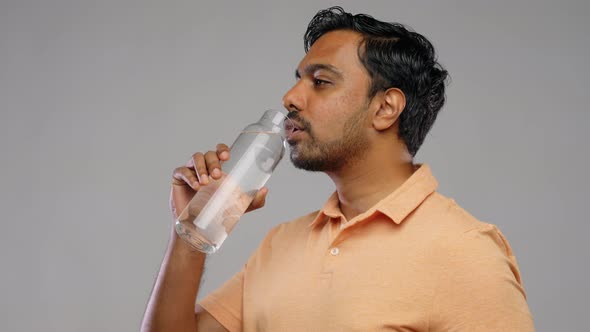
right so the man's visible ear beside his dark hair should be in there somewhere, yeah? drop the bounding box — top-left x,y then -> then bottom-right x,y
373,88 -> 406,131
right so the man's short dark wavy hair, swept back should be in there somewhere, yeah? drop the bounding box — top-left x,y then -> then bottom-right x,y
303,7 -> 448,156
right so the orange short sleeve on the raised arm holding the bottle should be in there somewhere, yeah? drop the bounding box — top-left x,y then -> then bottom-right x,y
199,265 -> 246,332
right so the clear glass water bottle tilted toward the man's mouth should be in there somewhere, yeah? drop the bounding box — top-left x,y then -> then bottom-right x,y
175,110 -> 290,254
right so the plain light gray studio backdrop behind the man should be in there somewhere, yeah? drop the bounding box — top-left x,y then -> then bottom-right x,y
0,0 -> 590,331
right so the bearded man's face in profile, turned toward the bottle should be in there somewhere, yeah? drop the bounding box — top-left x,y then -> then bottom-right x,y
283,31 -> 370,171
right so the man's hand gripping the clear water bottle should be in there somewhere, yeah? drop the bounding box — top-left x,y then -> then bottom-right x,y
170,144 -> 268,220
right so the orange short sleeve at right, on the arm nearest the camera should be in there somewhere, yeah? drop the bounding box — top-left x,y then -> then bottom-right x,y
429,224 -> 534,332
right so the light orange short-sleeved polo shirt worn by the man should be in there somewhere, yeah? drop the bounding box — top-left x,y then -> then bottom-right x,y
199,164 -> 534,331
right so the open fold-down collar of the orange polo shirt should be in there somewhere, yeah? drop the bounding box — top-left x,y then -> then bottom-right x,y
309,164 -> 438,227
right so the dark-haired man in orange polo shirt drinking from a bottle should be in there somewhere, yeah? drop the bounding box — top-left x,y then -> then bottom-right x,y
143,7 -> 534,331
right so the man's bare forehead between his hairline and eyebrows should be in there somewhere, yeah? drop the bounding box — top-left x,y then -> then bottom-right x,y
299,30 -> 364,75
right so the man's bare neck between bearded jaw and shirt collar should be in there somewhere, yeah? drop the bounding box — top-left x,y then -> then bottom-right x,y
327,139 -> 414,220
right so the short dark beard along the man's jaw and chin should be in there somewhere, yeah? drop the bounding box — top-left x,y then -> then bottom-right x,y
290,108 -> 369,172
